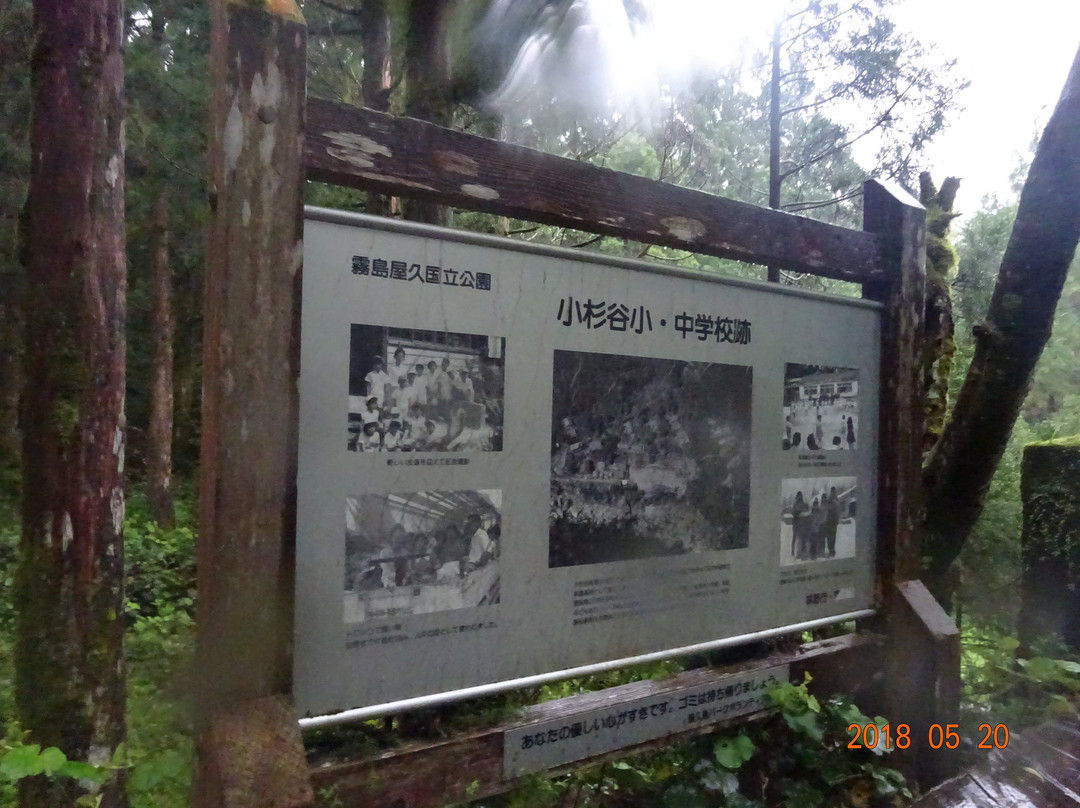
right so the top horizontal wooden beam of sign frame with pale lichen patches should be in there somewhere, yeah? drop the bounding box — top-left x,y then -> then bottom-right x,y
305,98 -> 886,283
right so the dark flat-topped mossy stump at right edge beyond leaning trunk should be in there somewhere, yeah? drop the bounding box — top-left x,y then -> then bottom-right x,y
1020,435 -> 1080,655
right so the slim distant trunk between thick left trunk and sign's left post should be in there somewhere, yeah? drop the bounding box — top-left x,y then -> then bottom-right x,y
146,193 -> 176,529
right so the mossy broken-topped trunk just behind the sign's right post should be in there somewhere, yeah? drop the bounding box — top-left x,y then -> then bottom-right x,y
919,172 -> 960,452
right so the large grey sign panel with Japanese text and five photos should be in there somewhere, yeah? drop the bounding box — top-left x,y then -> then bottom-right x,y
294,211 -> 880,714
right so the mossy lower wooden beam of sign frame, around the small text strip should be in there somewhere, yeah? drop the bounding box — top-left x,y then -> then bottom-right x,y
311,633 -> 881,808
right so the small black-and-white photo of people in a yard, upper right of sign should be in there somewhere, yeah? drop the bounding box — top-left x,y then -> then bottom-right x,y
783,363 -> 859,452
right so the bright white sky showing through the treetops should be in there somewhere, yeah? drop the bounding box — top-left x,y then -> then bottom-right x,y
490,0 -> 1080,211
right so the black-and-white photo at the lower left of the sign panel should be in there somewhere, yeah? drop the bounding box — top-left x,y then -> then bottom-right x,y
345,489 -> 502,623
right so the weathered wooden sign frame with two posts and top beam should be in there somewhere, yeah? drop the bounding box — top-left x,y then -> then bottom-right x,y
193,0 -> 959,807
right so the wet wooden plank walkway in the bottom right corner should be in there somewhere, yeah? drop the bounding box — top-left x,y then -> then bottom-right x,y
912,719 -> 1080,808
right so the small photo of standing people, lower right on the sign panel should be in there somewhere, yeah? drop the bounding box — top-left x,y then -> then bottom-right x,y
780,476 -> 856,567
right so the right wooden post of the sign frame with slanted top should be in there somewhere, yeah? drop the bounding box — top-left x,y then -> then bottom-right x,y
863,180 -> 960,786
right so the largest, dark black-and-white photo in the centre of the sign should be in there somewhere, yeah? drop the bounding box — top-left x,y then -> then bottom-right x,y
548,351 -> 753,567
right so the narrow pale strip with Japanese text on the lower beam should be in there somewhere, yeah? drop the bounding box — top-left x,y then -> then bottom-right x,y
502,664 -> 788,780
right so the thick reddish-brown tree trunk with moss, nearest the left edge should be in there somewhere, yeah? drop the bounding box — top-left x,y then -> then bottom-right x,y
15,0 -> 126,807
